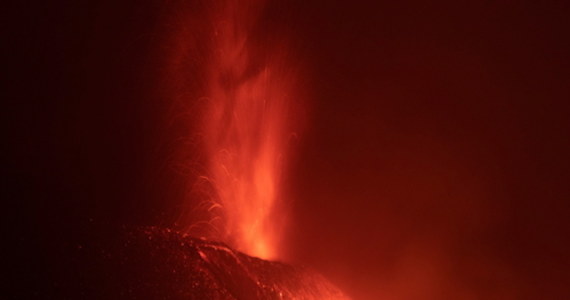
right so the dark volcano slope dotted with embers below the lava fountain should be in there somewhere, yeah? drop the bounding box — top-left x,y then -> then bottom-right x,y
113,227 -> 348,300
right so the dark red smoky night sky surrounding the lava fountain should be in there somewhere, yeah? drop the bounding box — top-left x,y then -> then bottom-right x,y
5,1 -> 570,299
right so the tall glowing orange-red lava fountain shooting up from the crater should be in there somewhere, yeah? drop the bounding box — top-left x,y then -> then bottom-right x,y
203,1 -> 300,259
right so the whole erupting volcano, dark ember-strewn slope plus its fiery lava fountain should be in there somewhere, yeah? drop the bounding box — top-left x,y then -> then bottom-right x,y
131,0 -> 346,299
